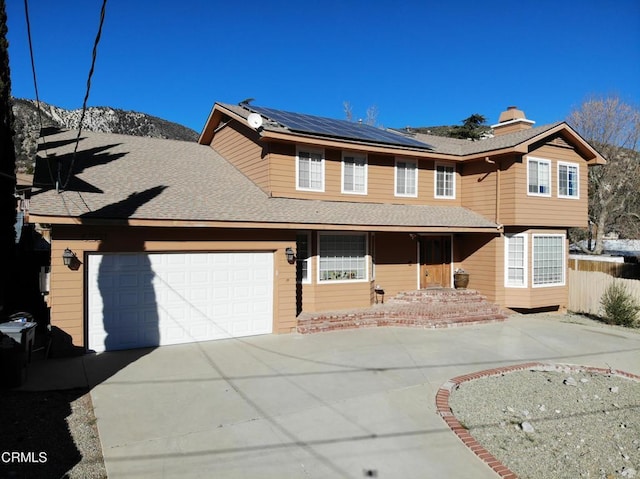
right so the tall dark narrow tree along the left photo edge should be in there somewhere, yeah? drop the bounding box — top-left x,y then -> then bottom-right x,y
0,0 -> 16,314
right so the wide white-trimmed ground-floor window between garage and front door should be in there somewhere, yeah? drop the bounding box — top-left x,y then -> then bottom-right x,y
318,233 -> 367,282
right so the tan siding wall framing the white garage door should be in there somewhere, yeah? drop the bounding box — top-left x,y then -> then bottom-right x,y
50,226 -> 297,346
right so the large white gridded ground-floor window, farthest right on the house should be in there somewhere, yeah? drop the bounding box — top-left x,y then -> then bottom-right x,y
532,234 -> 566,287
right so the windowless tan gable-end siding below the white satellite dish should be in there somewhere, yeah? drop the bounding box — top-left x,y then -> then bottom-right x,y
211,122 -> 269,193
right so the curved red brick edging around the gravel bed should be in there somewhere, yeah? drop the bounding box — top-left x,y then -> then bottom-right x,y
436,362 -> 640,479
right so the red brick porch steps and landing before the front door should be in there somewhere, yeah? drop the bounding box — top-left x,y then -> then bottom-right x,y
298,288 -> 508,334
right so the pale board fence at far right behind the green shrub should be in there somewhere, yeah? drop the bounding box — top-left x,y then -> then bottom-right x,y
568,270 -> 640,316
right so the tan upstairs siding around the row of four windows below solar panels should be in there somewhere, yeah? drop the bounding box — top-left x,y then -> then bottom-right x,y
269,143 -> 462,206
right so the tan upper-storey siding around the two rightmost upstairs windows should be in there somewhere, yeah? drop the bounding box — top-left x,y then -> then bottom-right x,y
500,144 -> 588,227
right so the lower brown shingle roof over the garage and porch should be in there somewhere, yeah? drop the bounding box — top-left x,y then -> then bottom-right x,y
30,131 -> 496,228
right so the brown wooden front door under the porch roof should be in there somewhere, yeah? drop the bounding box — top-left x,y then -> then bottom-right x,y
420,236 -> 451,289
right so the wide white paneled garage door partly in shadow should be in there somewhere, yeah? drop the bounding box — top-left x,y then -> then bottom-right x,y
88,253 -> 273,352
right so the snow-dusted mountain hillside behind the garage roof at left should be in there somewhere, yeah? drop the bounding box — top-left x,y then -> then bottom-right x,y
13,98 -> 199,173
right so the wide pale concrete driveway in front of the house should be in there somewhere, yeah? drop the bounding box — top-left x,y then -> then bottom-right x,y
75,315 -> 640,479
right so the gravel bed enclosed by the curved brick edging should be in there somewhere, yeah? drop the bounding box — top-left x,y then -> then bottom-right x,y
449,366 -> 640,479
